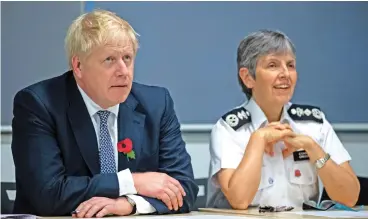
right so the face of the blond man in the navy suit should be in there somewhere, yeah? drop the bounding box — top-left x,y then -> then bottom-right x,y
74,40 -> 135,109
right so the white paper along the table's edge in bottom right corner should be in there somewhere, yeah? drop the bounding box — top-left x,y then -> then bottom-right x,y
287,211 -> 368,218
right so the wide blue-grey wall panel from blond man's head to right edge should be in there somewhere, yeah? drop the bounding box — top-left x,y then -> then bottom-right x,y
85,2 -> 368,123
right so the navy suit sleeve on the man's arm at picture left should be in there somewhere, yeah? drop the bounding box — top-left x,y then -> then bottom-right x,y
12,90 -> 119,216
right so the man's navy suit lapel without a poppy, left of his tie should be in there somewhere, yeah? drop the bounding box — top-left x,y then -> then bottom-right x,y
68,76 -> 100,175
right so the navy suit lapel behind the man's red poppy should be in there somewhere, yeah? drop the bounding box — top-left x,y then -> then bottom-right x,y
118,94 -> 145,172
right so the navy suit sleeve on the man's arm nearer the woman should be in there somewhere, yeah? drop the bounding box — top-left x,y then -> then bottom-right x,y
140,89 -> 198,214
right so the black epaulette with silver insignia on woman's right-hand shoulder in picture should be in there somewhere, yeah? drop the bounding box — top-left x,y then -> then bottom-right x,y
288,104 -> 323,123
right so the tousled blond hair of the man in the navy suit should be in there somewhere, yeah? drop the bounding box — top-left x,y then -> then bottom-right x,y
65,10 -> 139,68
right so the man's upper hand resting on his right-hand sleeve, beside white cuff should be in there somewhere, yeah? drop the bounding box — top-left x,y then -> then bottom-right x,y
132,172 -> 185,211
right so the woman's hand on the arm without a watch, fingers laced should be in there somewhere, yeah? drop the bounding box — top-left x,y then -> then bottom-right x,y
255,122 -> 295,156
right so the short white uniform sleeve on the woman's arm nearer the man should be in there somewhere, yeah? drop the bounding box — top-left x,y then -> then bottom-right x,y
210,120 -> 246,181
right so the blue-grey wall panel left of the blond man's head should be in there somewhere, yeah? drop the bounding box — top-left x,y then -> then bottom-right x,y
1,2 -> 83,125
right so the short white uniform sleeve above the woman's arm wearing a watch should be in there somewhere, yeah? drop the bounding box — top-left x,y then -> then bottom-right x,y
322,120 -> 351,165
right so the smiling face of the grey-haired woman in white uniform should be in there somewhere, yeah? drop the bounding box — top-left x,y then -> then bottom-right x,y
247,53 -> 298,106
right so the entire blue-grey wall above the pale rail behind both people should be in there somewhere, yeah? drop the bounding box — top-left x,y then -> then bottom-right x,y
1,2 -> 368,125
